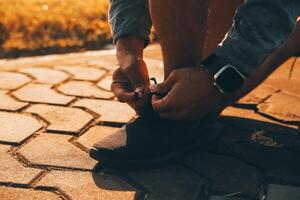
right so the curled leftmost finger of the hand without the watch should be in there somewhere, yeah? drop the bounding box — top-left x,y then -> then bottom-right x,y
111,83 -> 136,103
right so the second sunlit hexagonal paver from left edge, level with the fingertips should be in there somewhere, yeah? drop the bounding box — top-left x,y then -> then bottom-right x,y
12,83 -> 74,105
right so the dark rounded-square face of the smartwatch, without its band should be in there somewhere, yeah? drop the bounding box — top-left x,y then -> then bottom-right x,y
215,66 -> 244,93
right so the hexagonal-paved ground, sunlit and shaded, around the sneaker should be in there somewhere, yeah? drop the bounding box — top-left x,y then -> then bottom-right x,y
0,46 -> 300,200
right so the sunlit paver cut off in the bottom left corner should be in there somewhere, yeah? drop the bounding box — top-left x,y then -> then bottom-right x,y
0,186 -> 61,200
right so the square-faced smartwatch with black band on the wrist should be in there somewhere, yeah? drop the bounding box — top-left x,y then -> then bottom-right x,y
201,54 -> 245,95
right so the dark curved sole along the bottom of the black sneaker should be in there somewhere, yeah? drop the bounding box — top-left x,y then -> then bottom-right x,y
89,124 -> 221,170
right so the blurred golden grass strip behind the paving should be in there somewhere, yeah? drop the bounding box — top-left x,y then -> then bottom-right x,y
0,0 -> 111,57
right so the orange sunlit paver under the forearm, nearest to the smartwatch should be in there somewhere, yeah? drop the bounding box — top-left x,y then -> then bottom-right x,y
238,84 -> 278,104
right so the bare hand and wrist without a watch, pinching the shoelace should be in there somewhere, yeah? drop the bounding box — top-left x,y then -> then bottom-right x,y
111,36 -> 149,114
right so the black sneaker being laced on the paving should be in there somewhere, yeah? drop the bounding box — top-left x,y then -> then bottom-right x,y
90,113 -> 221,169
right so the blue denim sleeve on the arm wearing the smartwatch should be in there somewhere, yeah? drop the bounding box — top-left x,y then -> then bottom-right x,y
215,0 -> 300,76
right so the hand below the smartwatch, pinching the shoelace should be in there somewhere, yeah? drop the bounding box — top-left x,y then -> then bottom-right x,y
150,67 -> 222,121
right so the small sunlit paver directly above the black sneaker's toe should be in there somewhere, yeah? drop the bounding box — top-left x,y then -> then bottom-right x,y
77,126 -> 118,149
